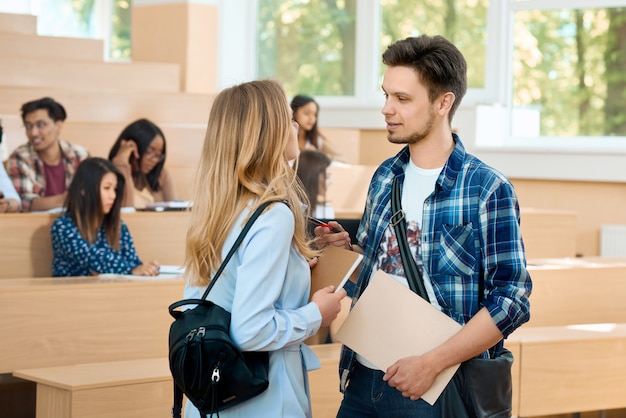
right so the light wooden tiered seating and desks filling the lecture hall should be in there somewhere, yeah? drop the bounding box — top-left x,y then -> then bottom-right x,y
0,9 -> 626,418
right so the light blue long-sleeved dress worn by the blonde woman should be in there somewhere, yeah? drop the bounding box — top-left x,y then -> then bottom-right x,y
184,203 -> 322,418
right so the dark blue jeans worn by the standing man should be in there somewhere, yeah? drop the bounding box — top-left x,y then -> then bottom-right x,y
337,361 -> 441,418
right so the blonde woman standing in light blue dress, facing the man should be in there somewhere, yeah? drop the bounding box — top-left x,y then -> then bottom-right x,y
184,80 -> 345,418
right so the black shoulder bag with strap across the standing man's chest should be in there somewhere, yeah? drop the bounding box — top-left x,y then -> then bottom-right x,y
391,178 -> 513,418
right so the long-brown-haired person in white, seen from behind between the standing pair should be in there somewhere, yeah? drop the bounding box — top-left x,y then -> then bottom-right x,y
296,149 -> 335,219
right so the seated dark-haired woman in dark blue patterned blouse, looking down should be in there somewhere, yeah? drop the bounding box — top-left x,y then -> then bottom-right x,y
51,158 -> 159,276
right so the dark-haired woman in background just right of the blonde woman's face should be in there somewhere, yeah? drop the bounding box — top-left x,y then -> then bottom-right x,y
291,94 -> 341,160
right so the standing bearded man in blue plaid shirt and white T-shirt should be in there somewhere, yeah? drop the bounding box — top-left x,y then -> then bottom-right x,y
316,36 -> 532,418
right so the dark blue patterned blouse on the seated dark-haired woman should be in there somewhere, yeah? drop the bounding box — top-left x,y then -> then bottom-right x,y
50,214 -> 141,277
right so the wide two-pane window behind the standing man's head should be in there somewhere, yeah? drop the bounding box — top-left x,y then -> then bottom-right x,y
256,0 -> 489,96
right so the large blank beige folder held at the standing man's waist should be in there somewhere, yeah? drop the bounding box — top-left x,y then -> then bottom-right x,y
335,270 -> 461,405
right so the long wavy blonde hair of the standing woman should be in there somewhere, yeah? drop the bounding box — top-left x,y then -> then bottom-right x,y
185,80 -> 316,286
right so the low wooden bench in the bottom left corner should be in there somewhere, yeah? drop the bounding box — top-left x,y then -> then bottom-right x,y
13,357 -> 173,418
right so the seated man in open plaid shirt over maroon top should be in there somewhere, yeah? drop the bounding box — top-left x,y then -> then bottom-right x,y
8,97 -> 89,212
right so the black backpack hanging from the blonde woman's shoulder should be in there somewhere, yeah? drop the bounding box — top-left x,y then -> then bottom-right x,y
169,202 -> 273,418
